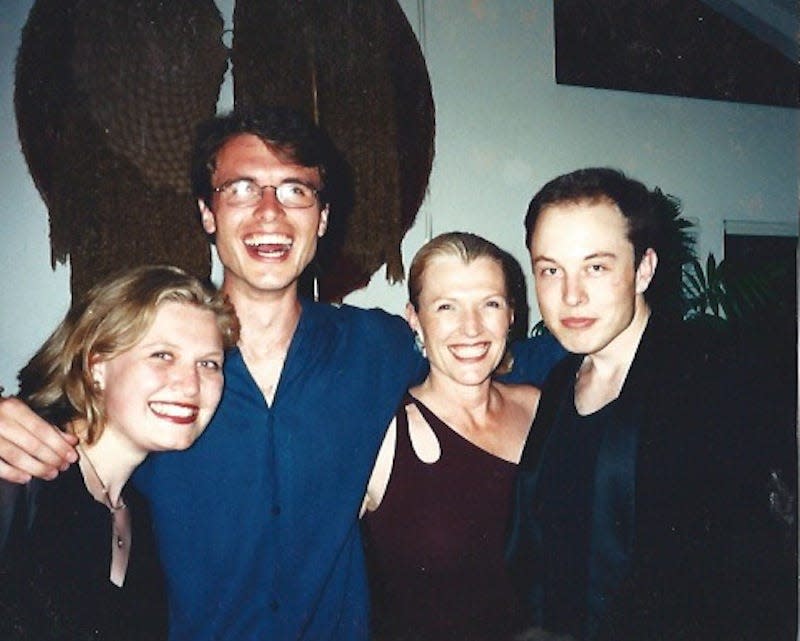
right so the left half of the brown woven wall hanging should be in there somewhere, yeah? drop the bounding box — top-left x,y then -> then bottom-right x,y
14,0 -> 227,296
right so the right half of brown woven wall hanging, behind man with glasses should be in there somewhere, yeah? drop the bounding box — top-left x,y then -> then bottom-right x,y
232,0 -> 434,300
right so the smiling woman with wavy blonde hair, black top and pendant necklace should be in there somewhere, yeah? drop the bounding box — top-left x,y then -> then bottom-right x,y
0,266 -> 238,641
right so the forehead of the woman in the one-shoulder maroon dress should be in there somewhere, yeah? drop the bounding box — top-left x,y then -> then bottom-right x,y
420,254 -> 506,296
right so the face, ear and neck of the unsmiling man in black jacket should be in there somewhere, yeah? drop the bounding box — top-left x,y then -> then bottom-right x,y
530,201 -> 658,415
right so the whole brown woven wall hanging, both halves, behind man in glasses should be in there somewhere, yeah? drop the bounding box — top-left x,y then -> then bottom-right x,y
14,0 -> 434,300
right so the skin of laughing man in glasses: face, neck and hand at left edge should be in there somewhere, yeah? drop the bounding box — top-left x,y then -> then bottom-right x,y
0,134 -> 328,483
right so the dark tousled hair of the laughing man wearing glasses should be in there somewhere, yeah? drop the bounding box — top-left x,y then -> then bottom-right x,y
191,106 -> 344,209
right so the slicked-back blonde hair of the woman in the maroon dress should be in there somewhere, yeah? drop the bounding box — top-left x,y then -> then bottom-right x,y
408,231 -> 516,374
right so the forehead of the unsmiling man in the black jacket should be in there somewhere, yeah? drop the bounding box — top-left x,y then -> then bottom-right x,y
531,201 -> 633,259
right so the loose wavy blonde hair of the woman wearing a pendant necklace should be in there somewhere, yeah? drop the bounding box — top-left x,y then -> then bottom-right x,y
19,265 -> 239,443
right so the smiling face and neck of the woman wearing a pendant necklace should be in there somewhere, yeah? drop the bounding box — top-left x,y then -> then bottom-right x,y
79,302 -> 224,500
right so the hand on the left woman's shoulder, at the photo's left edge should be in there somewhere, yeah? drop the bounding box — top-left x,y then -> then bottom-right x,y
0,397 -> 77,483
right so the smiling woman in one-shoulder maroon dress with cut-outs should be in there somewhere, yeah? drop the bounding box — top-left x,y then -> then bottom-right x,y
363,232 -> 539,641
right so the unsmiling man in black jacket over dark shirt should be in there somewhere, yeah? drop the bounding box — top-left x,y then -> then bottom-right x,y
508,169 -> 792,641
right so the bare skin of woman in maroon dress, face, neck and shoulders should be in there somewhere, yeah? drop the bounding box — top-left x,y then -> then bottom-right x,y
361,255 -> 539,515
